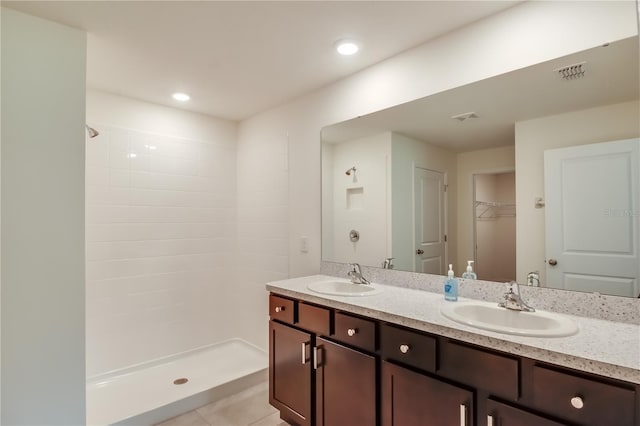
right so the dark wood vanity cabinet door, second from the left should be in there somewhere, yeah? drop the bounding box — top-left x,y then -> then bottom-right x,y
315,338 -> 376,426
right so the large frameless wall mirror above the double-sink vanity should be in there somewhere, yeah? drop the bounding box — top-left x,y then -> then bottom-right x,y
322,37 -> 640,297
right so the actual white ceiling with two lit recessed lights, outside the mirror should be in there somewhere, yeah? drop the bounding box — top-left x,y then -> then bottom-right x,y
2,0 -> 518,120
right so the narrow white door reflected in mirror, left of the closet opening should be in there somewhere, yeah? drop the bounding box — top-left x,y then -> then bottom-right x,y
414,167 -> 447,275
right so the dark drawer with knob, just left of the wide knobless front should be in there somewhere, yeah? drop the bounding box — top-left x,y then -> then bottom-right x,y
380,324 -> 436,372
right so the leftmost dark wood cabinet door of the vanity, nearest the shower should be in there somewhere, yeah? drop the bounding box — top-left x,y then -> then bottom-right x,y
269,321 -> 312,426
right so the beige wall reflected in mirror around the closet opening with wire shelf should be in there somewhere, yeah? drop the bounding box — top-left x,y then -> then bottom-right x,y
454,146 -> 515,274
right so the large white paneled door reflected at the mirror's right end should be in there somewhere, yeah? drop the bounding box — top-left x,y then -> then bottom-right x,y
544,139 -> 640,297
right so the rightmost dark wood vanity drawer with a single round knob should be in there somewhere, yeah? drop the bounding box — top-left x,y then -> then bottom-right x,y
532,365 -> 640,426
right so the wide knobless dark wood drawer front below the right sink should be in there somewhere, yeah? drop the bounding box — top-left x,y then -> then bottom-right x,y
440,340 -> 520,401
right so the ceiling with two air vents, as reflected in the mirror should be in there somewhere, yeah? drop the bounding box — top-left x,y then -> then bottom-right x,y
322,37 -> 640,152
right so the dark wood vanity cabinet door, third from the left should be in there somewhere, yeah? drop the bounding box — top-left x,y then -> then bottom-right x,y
381,361 -> 474,426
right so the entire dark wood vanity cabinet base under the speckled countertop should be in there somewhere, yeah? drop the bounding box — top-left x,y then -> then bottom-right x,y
269,295 -> 640,426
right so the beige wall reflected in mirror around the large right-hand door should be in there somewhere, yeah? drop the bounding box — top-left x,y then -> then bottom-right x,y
516,102 -> 640,286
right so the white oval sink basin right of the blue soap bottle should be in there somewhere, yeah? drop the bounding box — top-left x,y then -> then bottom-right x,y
440,301 -> 578,337
